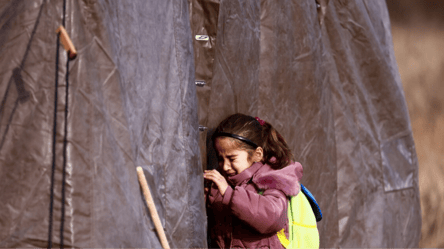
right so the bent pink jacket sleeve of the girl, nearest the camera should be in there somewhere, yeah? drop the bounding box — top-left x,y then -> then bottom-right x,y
223,186 -> 288,234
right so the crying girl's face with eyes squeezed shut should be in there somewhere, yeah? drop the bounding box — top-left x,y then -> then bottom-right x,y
214,137 -> 262,176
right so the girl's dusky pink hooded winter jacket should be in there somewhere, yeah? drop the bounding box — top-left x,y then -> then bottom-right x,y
208,162 -> 302,248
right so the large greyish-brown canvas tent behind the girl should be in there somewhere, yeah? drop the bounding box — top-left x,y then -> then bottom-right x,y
0,0 -> 421,248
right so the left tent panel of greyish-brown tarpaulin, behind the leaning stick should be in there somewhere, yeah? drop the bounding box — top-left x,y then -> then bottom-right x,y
0,0 -> 206,248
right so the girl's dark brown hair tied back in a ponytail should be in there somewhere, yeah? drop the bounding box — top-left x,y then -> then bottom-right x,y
212,113 -> 294,169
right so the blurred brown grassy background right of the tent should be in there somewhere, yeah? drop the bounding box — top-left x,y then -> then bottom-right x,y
387,0 -> 444,248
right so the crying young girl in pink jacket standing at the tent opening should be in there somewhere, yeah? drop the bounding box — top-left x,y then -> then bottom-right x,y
204,114 -> 302,248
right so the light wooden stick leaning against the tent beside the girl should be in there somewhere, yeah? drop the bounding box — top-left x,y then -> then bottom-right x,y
137,166 -> 170,249
